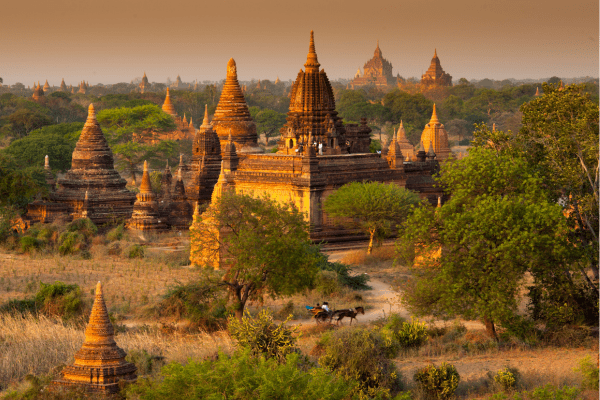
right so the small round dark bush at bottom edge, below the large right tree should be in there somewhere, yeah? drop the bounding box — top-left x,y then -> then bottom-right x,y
414,363 -> 460,400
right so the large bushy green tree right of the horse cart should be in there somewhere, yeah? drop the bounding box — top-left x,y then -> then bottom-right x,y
399,148 -> 579,339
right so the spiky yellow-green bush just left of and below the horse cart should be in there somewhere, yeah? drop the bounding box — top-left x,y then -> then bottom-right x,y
228,309 -> 298,362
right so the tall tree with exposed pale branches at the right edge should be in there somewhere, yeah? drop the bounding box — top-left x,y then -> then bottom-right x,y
513,83 -> 600,280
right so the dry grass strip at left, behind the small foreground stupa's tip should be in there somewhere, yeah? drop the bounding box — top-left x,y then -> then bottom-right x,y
0,245 -> 197,314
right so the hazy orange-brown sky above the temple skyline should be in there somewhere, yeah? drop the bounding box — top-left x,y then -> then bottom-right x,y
0,0 -> 599,86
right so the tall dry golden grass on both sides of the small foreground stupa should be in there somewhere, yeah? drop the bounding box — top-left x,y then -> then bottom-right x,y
0,315 -> 232,388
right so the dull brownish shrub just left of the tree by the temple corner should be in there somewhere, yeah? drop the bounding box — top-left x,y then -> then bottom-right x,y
156,277 -> 227,331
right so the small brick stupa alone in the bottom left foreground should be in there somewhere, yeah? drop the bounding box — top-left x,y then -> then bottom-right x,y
51,282 -> 137,395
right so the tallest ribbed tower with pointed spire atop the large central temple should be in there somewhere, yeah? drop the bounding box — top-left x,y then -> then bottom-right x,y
278,31 -> 348,154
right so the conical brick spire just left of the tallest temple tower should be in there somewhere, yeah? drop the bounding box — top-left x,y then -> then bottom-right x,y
212,58 -> 262,153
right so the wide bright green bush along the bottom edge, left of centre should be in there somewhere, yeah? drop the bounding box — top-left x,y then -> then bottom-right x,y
127,351 -> 356,400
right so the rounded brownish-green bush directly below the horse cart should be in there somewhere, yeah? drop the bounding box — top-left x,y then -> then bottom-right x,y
318,328 -> 400,397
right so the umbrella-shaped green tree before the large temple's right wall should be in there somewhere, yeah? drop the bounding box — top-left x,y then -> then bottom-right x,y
323,182 -> 419,254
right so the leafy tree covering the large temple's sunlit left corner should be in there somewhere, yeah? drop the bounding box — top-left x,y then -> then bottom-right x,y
190,192 -> 319,320
